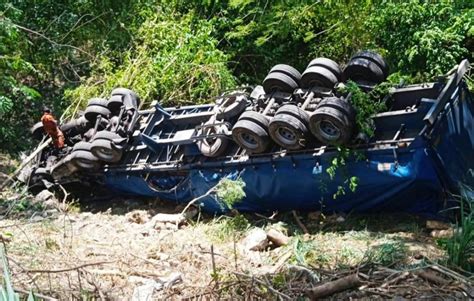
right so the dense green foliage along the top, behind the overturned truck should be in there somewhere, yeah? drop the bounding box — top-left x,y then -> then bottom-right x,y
0,0 -> 474,152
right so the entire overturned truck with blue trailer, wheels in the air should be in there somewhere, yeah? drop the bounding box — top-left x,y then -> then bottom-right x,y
28,51 -> 474,214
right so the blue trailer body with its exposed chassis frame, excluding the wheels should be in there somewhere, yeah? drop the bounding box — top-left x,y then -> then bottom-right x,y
105,61 -> 474,215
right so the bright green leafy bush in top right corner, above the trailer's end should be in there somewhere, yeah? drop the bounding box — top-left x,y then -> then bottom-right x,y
367,0 -> 474,80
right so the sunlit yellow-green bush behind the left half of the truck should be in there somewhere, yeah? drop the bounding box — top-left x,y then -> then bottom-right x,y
67,11 -> 235,113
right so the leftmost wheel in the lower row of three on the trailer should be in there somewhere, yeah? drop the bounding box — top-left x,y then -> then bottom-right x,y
232,115 -> 270,154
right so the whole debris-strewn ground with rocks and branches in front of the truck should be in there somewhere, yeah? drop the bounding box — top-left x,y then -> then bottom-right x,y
0,166 -> 473,300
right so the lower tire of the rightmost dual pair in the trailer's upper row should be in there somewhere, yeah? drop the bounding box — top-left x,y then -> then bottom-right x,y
344,58 -> 385,84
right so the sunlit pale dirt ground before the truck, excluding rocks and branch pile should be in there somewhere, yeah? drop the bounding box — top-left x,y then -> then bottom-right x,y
0,184 -> 462,300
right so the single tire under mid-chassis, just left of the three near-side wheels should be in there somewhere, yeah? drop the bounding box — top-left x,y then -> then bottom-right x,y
196,121 -> 229,157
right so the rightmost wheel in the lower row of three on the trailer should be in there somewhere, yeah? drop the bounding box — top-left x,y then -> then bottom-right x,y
309,107 -> 354,145
